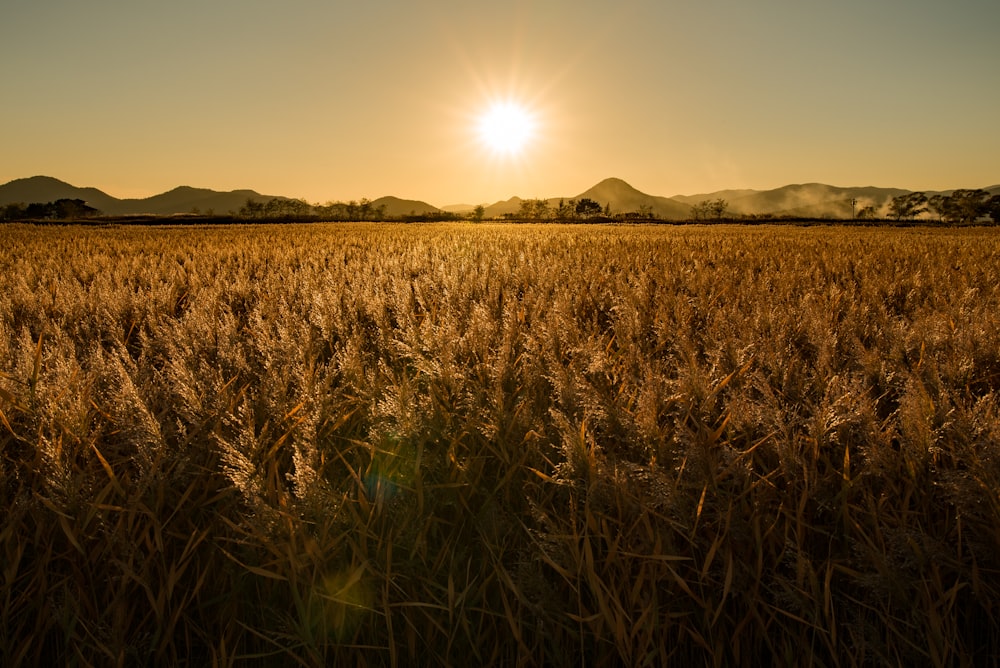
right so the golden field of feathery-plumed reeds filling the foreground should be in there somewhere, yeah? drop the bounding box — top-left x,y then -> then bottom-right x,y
0,224 -> 1000,666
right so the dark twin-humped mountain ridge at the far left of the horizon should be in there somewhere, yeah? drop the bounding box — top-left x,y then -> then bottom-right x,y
0,176 -> 286,216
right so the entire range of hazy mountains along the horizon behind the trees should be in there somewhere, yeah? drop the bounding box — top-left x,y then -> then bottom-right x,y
0,176 -> 1000,220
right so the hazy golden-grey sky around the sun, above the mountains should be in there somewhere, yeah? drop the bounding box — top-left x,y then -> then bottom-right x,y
0,0 -> 1000,206
